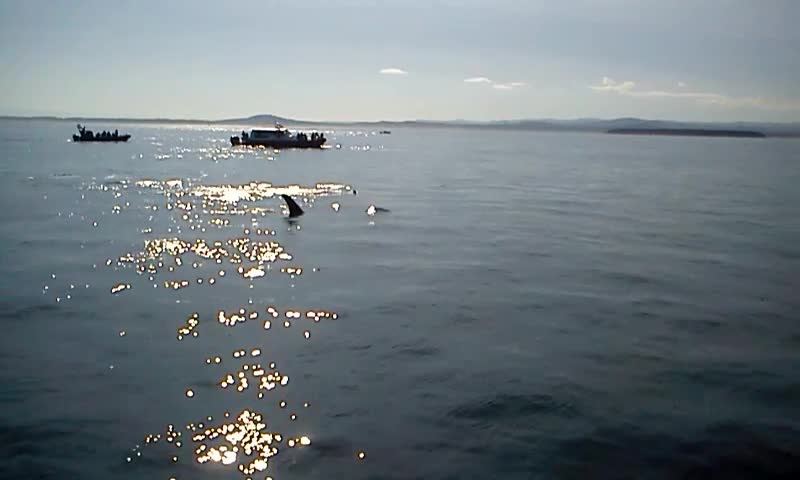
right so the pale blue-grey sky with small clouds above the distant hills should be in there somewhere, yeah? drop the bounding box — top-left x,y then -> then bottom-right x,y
0,0 -> 800,121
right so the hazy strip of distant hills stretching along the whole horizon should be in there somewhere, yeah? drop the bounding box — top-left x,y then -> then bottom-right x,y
0,114 -> 800,137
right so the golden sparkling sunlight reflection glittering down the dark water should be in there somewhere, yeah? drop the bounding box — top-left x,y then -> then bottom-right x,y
90,174 -> 364,478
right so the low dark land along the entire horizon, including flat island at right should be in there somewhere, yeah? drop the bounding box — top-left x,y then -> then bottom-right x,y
0,114 -> 800,138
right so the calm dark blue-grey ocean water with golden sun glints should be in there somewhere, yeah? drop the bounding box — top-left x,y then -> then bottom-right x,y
0,121 -> 800,480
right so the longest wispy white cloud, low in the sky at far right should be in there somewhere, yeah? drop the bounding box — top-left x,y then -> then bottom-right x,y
589,77 -> 800,110
